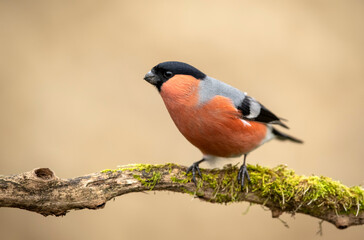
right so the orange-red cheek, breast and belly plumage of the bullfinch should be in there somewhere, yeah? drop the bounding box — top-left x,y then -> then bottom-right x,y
160,75 -> 267,157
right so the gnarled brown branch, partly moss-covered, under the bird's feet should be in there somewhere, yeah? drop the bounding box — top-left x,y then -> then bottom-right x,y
0,163 -> 364,229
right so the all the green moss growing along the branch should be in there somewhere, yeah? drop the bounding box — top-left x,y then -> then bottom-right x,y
102,163 -> 364,214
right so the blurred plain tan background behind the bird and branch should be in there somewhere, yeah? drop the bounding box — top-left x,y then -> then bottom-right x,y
0,0 -> 364,240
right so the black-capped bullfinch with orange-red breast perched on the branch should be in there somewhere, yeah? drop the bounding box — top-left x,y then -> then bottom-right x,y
144,61 -> 303,189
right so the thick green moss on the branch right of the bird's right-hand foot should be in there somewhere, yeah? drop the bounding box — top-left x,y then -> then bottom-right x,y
249,165 -> 364,213
